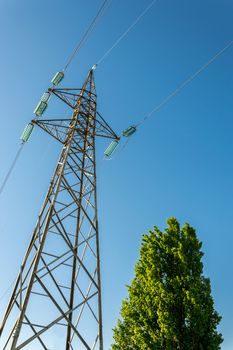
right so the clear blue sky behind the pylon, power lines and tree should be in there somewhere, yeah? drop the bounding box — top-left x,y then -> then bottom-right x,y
0,0 -> 233,350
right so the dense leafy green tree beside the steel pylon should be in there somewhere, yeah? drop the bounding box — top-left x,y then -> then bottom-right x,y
112,218 -> 223,350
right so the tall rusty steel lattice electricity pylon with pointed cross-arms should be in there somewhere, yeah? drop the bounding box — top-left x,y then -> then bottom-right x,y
0,70 -> 118,350
